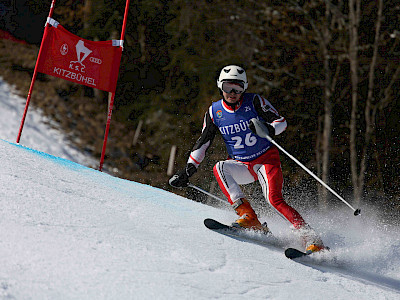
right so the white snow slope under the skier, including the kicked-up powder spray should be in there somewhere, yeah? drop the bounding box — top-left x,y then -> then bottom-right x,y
0,81 -> 400,300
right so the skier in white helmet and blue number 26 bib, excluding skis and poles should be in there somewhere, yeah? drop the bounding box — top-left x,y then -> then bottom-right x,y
169,65 -> 325,253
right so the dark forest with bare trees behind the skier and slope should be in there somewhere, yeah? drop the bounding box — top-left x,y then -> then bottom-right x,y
0,0 -> 400,216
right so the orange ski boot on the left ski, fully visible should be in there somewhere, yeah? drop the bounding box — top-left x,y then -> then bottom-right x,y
232,198 -> 270,233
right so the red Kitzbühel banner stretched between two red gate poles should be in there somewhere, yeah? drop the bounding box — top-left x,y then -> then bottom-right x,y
37,24 -> 122,93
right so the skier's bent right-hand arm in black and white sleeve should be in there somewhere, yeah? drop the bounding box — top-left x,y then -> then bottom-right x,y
253,95 -> 287,136
